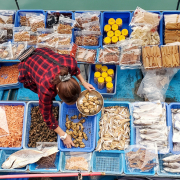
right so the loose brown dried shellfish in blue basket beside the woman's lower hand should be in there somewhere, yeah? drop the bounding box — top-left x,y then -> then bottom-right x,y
65,113 -> 88,148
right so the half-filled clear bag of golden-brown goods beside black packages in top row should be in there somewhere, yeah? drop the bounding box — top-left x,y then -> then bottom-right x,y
57,15 -> 75,34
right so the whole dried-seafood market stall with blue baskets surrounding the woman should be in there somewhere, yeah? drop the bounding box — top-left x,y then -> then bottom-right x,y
0,7 -> 180,179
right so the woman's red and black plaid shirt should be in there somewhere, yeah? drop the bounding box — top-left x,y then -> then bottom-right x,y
18,48 -> 80,129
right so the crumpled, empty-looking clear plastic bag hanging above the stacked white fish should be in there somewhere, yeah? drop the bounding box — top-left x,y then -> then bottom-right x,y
137,68 -> 178,102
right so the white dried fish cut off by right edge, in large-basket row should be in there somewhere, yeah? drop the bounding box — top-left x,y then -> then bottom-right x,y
171,109 -> 180,151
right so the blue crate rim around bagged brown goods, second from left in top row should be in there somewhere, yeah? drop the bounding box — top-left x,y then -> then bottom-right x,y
15,9 -> 46,27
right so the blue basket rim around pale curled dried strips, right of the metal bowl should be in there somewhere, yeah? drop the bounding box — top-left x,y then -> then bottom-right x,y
96,101 -> 134,153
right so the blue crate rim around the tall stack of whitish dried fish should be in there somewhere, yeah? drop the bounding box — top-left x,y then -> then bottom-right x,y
131,102 -> 172,153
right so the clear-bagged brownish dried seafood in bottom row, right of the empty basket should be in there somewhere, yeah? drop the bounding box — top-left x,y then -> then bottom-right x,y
125,148 -> 157,171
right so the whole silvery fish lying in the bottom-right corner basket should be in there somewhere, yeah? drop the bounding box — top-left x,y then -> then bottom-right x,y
162,154 -> 180,173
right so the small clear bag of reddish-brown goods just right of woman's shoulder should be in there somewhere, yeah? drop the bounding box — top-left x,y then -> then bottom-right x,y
75,47 -> 97,63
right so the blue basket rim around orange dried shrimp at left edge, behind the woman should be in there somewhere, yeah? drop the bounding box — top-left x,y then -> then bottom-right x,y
0,61 -> 21,90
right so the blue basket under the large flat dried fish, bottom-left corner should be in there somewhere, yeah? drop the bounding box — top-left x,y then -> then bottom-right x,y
0,150 -> 27,172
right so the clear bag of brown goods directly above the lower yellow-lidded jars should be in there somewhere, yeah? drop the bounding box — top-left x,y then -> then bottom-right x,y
99,45 -> 120,64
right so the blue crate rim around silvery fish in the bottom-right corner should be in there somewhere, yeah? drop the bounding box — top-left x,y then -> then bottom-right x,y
157,154 -> 180,177
